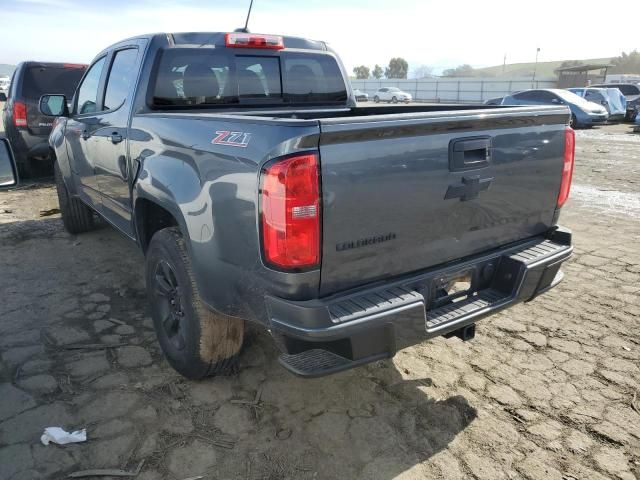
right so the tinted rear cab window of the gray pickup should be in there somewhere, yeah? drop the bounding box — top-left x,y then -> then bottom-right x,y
151,48 -> 347,109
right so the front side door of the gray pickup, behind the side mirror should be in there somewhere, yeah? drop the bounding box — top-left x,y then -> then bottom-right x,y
65,56 -> 107,211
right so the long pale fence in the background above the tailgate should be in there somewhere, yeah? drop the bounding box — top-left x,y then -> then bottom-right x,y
351,77 -> 557,103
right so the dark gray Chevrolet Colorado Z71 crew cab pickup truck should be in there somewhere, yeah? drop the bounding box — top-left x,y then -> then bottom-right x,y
27,33 -> 574,378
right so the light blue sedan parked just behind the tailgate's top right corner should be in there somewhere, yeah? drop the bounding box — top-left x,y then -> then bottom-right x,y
502,88 -> 609,128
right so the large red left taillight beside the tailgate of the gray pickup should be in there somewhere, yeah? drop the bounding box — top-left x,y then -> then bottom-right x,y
261,153 -> 321,269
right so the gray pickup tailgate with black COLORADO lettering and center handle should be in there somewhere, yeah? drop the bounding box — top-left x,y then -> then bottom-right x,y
320,107 -> 568,295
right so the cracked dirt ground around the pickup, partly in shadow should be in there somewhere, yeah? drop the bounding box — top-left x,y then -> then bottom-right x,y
0,119 -> 640,480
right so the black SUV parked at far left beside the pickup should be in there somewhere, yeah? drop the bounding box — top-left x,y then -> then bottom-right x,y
2,62 -> 86,177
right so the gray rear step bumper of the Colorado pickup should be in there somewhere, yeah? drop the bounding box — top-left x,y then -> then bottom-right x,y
266,228 -> 573,377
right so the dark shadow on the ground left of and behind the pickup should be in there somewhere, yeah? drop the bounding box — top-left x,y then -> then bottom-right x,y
0,215 -> 477,480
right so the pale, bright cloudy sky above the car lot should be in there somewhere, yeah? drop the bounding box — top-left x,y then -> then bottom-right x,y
0,0 -> 640,73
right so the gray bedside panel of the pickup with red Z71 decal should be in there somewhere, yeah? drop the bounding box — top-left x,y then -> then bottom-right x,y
129,113 -> 319,321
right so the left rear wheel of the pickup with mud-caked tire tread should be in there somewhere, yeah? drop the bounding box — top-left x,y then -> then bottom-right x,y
145,227 -> 244,379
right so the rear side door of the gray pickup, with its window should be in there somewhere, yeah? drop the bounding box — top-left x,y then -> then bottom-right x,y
93,45 -> 142,236
